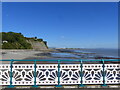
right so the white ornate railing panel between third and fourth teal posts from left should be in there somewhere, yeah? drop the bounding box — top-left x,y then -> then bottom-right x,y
60,64 -> 81,85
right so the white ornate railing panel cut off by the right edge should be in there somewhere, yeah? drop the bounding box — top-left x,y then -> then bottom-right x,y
105,64 -> 120,84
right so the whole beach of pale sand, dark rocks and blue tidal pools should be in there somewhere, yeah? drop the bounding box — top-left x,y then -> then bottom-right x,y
0,49 -> 119,64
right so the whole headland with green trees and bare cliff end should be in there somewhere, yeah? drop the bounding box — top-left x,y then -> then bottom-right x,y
0,32 -> 48,50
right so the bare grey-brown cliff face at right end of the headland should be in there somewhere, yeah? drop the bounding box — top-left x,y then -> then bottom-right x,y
27,40 -> 48,50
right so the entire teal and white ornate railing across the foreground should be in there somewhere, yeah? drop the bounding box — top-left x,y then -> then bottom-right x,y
0,59 -> 120,87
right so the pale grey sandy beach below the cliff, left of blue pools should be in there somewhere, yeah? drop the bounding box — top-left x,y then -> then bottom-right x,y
0,49 -> 78,64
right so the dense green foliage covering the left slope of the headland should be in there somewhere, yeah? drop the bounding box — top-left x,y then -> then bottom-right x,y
0,32 -> 32,49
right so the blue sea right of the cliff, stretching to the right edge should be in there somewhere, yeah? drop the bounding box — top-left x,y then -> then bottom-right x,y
52,48 -> 120,59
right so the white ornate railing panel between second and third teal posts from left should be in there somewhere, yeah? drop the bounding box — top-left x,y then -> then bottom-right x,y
36,64 -> 58,85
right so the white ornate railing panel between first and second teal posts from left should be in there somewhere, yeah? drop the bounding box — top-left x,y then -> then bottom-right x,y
12,64 -> 34,85
